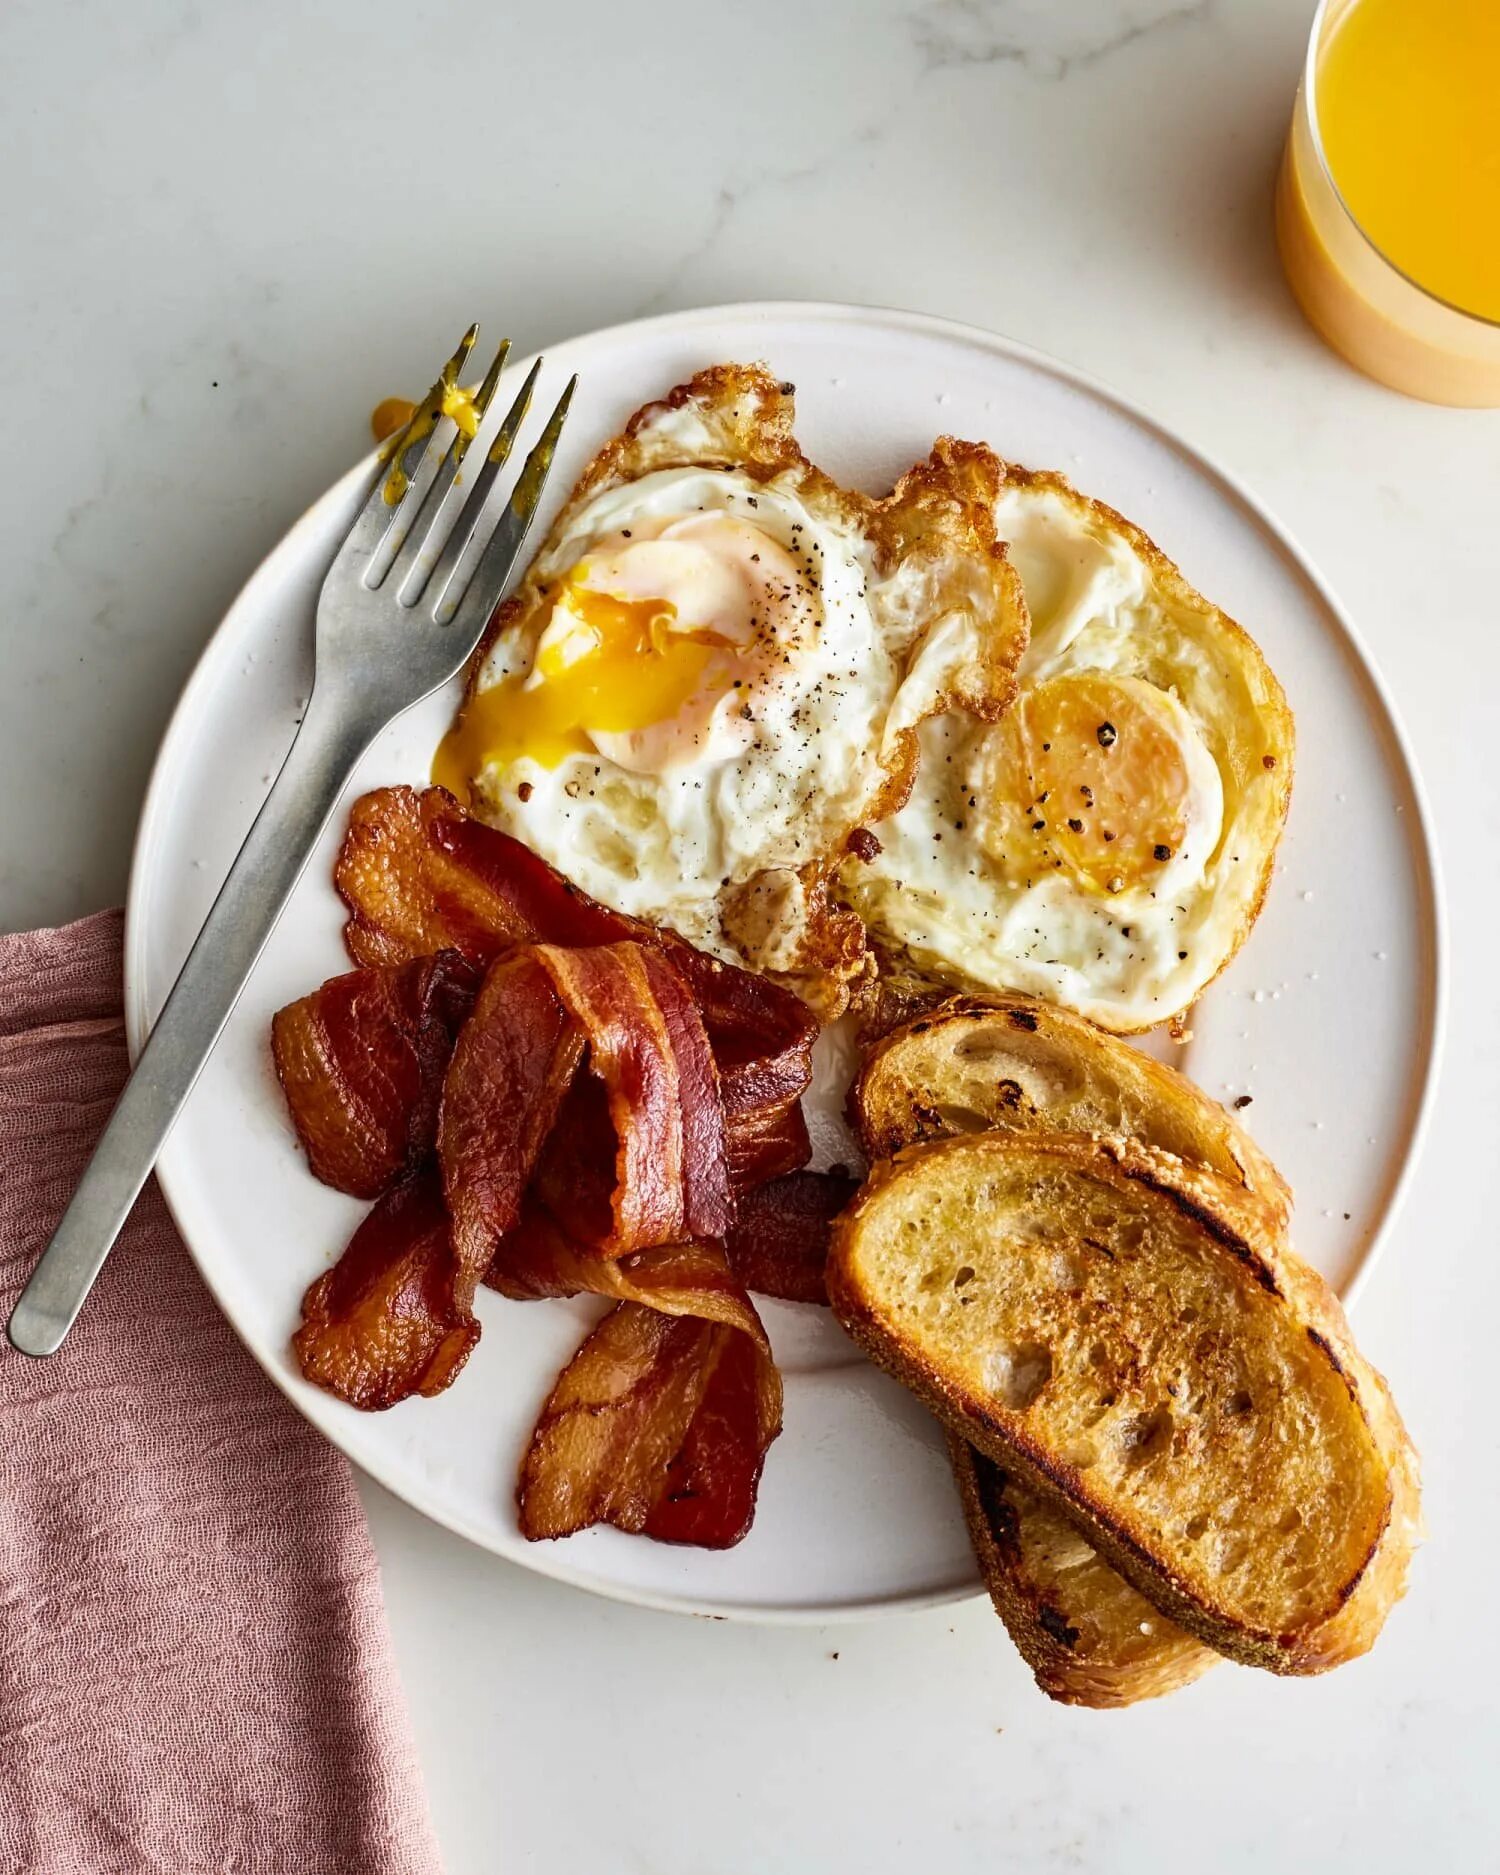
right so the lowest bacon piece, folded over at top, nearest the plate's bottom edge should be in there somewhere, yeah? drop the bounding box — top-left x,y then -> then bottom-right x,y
518,1232 -> 782,1549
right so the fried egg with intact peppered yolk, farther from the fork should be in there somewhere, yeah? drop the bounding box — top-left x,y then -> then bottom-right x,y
842,467 -> 1292,1033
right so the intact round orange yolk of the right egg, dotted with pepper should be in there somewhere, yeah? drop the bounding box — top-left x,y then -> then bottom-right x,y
984,671 -> 1223,894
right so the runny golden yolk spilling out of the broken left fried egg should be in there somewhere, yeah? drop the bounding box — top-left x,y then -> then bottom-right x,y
433,566 -> 722,804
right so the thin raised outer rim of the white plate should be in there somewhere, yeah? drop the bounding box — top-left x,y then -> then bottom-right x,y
124,300 -> 1449,1626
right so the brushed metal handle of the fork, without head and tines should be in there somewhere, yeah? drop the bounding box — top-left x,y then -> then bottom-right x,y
8,688 -> 379,1356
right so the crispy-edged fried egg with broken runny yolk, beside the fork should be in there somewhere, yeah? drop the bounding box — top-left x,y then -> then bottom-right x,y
433,366 -> 1026,1013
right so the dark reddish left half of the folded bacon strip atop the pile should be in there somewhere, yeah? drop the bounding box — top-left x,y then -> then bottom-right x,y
437,947 -> 585,1307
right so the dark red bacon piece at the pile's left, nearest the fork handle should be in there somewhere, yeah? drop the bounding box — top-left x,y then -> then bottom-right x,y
272,951 -> 480,1198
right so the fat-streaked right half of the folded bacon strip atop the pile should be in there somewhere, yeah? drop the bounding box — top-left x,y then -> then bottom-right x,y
534,943 -> 733,1256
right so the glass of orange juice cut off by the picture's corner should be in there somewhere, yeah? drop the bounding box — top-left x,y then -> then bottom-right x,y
1277,0 -> 1500,405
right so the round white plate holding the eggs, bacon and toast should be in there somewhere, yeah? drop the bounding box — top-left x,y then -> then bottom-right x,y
126,304 -> 1440,1620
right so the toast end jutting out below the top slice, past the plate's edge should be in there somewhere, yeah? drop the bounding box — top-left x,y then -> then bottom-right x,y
949,1433 -> 1219,1708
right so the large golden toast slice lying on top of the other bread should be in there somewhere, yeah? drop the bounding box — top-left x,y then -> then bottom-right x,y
829,1133 -> 1419,1673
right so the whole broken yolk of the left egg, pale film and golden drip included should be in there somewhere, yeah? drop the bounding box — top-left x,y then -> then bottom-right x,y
433,514 -> 816,801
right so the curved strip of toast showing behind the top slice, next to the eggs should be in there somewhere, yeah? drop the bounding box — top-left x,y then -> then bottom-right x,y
849,994 -> 1292,1230
